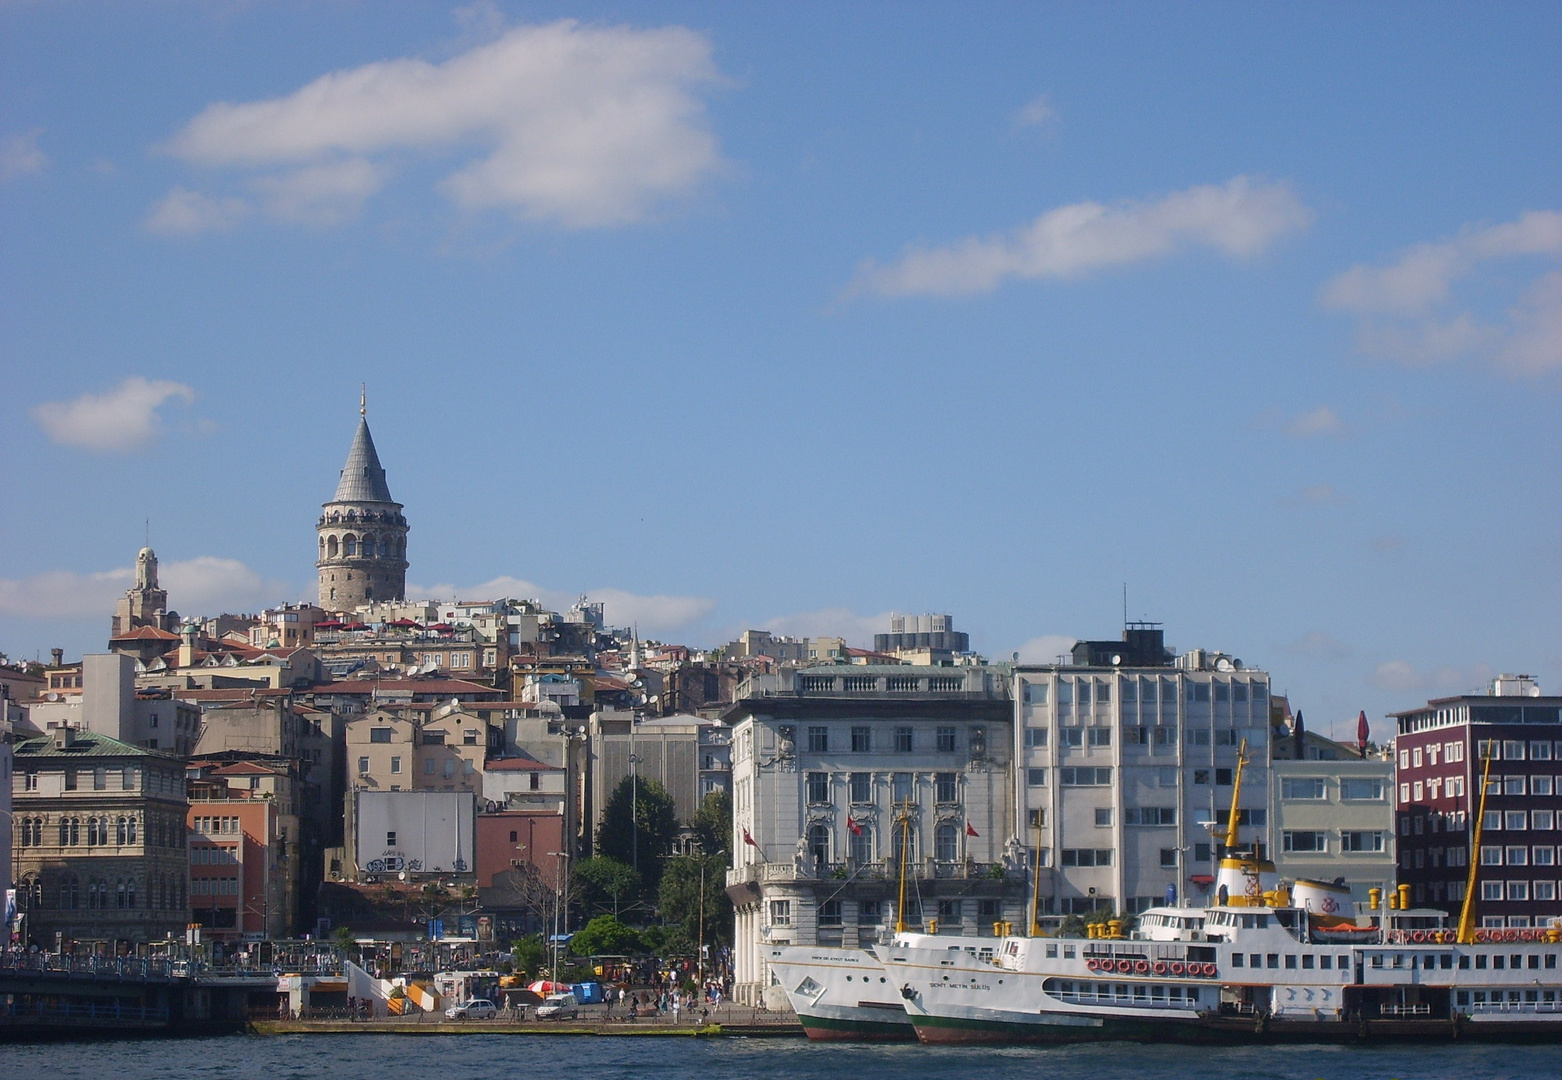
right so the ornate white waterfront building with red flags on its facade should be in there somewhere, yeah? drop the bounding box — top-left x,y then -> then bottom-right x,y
723,666 -> 1028,1002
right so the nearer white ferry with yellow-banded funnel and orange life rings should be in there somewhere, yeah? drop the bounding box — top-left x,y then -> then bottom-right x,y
883,747 -> 1562,1042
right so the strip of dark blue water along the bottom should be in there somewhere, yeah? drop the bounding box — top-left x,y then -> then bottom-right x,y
0,1035 -> 1562,1080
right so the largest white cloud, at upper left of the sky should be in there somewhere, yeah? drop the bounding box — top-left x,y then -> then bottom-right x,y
156,19 -> 722,228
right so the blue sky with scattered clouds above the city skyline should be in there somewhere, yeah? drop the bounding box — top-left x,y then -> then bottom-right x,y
0,0 -> 1562,736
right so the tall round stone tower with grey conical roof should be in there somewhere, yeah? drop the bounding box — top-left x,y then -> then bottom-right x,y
316,395 -> 406,611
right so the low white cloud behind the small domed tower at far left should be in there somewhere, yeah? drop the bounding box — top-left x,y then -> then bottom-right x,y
0,555 -> 292,615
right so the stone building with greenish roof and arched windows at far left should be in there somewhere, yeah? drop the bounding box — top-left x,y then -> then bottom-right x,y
12,728 -> 189,947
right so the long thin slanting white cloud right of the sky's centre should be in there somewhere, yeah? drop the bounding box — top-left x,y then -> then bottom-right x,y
847,177 -> 1312,297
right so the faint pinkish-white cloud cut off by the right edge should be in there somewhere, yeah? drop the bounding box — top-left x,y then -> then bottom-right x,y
1318,209 -> 1562,377
